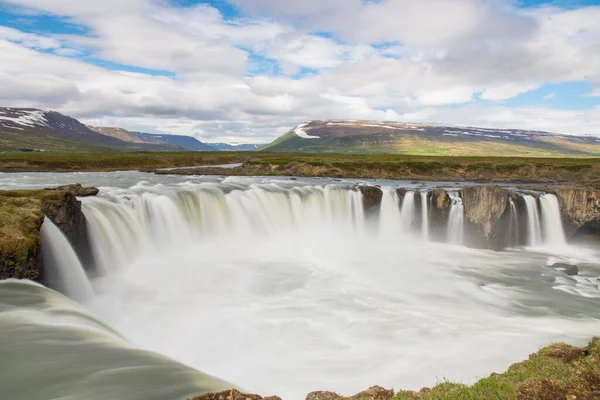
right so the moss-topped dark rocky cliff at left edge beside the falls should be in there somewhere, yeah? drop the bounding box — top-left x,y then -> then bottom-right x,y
0,185 -> 97,281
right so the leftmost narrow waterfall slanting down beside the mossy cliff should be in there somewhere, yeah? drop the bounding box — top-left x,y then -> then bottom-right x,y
40,218 -> 94,300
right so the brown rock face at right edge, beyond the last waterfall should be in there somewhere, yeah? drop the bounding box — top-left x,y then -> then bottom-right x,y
550,188 -> 600,237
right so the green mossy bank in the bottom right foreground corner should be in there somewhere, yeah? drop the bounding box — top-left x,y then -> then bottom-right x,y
394,338 -> 600,400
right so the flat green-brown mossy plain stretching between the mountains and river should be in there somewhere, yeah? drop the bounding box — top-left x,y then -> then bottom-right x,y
0,152 -> 600,186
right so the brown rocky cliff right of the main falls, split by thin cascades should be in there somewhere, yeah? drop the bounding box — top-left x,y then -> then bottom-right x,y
360,186 -> 600,250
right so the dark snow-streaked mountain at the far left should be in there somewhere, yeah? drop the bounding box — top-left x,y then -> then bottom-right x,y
0,107 -> 184,152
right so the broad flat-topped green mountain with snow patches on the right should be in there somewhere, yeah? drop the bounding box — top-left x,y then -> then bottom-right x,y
260,120 -> 600,156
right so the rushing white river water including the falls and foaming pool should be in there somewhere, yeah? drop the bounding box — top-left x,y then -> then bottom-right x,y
0,172 -> 600,400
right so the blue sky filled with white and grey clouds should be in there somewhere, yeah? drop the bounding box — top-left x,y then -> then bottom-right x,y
0,0 -> 600,143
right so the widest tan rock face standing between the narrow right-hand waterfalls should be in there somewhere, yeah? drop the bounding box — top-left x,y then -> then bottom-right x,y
460,186 -> 510,250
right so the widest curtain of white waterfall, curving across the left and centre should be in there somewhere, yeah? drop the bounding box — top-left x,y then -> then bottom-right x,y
83,184 -> 366,271
